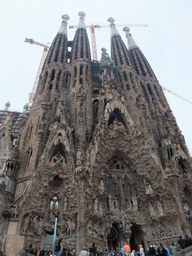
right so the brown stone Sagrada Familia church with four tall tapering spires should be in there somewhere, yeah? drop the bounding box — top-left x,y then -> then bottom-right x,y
0,12 -> 192,256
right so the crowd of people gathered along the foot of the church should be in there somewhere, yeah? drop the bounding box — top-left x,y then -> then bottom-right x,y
26,235 -> 192,256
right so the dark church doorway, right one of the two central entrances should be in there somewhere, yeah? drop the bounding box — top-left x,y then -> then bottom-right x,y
130,224 -> 144,251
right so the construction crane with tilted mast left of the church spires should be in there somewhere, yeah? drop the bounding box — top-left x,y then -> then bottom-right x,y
25,38 -> 49,109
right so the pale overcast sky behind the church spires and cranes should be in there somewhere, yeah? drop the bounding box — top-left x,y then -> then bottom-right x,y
0,0 -> 192,152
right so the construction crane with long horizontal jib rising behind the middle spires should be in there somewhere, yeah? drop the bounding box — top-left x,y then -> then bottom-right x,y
69,24 -> 147,62
